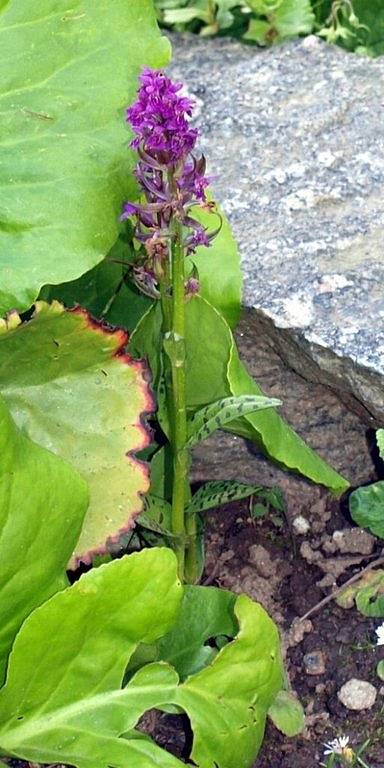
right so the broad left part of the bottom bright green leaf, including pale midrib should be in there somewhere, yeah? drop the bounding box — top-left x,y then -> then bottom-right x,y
0,549 -> 182,768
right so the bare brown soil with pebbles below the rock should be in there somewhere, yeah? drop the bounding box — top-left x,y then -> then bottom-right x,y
208,495 -> 384,768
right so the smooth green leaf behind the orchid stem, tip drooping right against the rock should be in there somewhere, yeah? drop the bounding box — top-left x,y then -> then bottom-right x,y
130,296 -> 348,493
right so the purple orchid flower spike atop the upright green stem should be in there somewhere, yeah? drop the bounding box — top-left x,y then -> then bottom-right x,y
121,68 -> 221,298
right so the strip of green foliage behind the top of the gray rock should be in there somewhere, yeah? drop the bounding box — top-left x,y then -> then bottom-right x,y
155,0 -> 384,56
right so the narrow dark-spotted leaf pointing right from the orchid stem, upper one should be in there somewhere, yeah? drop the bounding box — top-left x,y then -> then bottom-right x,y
187,395 -> 281,448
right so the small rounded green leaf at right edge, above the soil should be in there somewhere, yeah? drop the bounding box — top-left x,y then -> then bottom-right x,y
349,480 -> 384,539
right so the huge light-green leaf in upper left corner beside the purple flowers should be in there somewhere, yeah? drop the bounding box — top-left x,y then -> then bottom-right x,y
0,0 -> 170,313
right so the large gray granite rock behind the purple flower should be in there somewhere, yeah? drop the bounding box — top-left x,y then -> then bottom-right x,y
170,37 -> 384,424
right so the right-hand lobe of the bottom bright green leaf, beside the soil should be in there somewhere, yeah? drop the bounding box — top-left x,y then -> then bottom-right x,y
174,595 -> 282,768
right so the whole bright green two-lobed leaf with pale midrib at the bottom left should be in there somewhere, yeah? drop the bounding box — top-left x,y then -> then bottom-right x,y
0,564 -> 282,768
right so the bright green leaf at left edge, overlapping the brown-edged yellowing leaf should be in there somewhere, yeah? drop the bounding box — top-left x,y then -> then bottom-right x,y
0,398 -> 88,683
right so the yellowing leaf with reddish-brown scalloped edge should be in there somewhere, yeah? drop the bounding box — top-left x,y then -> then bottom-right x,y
0,302 -> 154,566
